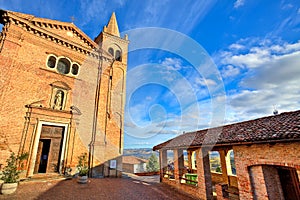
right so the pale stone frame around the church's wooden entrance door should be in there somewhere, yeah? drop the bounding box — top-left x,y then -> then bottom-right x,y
28,121 -> 69,176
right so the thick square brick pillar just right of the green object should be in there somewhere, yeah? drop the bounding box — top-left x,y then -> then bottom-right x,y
196,148 -> 213,199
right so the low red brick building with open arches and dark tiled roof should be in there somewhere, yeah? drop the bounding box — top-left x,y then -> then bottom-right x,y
153,111 -> 300,200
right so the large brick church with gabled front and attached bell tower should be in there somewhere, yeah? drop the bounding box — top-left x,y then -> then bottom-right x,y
0,10 -> 129,177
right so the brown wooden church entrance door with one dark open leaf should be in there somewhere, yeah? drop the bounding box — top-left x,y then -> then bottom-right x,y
34,125 -> 65,174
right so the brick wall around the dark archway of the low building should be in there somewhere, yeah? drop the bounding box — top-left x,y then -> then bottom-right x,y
233,142 -> 300,199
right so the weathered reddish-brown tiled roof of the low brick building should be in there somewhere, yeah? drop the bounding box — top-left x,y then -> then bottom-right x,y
153,110 -> 300,150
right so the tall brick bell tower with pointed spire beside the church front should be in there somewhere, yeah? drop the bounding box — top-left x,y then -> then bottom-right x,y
92,13 -> 129,177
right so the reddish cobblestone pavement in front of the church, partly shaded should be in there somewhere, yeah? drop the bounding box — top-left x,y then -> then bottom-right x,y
0,177 -> 197,200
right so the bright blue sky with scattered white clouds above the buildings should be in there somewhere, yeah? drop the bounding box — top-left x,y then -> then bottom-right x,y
0,0 -> 300,148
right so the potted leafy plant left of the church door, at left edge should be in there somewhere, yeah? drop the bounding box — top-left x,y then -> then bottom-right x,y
1,152 -> 28,194
